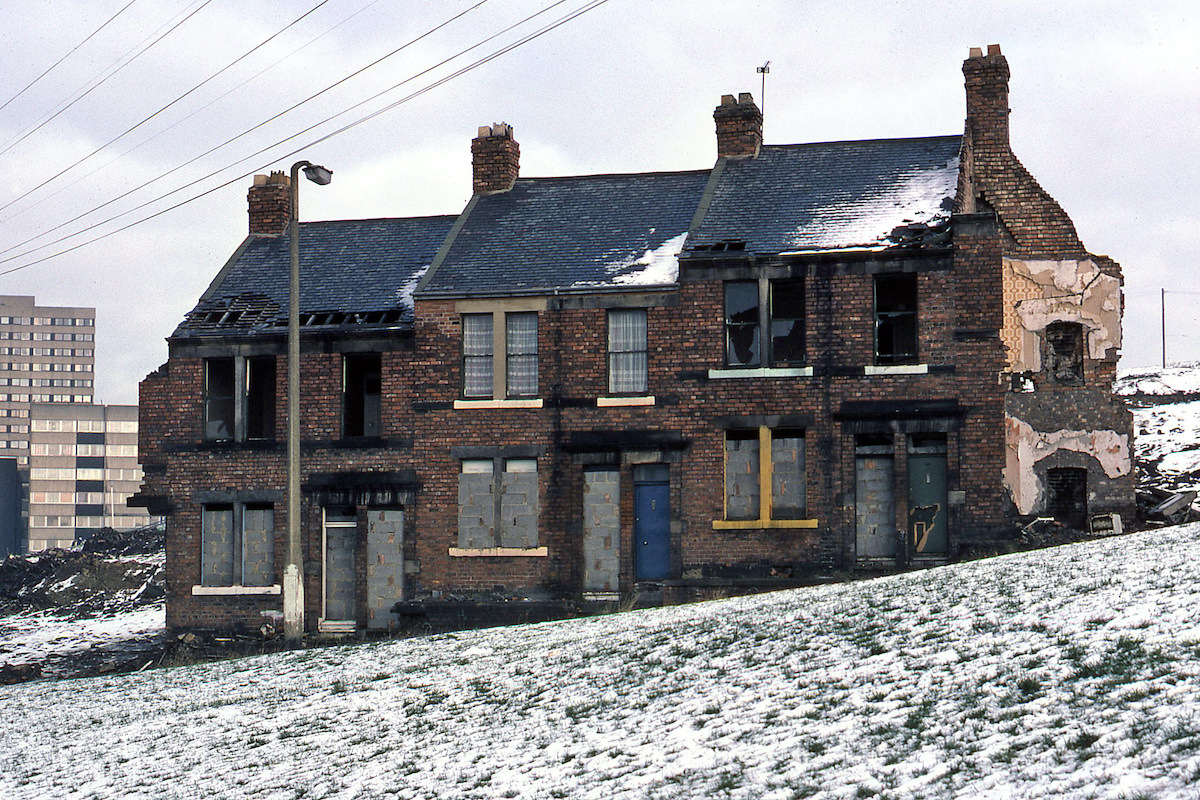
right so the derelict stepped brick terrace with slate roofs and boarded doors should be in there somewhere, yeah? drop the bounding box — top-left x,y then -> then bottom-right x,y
133,47 -> 1133,632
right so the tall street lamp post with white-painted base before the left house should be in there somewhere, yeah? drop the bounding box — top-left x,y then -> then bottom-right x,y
283,161 -> 334,639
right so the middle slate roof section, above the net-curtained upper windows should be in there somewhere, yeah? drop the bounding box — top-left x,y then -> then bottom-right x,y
420,169 -> 709,295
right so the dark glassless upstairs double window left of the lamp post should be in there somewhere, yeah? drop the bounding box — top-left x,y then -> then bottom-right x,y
204,356 -> 275,441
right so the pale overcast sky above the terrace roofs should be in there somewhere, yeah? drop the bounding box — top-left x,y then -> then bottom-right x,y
0,0 -> 1200,403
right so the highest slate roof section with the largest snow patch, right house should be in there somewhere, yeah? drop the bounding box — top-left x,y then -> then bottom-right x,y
688,136 -> 962,253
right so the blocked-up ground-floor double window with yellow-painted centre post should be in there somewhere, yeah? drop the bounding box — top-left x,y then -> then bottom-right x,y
725,428 -> 808,521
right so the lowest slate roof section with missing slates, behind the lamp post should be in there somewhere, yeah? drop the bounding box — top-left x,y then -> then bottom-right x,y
172,216 -> 456,337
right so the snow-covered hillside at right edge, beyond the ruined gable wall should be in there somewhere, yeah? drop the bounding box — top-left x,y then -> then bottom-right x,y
1116,365 -> 1200,491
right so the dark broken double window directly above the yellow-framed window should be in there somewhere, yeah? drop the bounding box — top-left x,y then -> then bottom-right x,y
725,278 -> 805,367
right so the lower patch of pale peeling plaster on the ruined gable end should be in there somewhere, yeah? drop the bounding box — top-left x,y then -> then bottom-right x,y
1004,415 -> 1133,515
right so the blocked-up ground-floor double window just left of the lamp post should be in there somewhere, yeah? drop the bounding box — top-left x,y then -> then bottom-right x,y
200,503 -> 275,587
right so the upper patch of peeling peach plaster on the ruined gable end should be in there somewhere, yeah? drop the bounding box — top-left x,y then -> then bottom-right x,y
1001,258 -> 1121,372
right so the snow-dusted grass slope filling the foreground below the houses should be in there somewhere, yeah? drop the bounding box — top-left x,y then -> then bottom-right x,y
0,525 -> 1200,800
